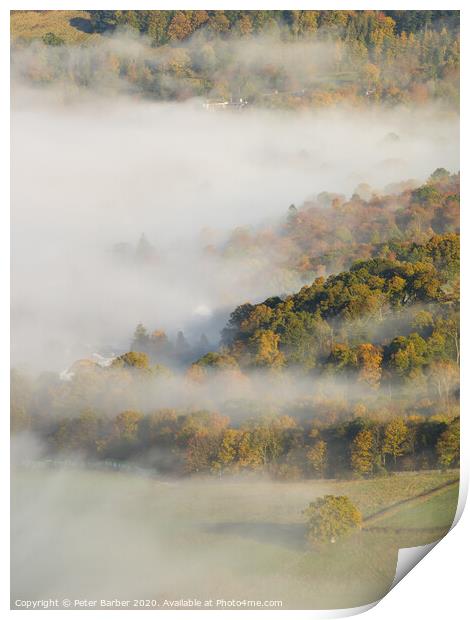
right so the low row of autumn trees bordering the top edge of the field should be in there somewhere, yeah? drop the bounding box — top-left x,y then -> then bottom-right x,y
13,408 -> 460,480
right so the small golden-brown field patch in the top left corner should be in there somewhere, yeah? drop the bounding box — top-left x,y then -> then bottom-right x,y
10,11 -> 100,43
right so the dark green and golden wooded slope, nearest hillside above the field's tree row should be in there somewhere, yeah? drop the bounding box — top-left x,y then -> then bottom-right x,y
193,233 -> 460,392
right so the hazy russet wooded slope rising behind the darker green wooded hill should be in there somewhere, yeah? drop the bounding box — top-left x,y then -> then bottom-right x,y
220,171 -> 460,281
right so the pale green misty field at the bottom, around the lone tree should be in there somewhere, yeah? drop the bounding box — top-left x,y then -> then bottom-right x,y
12,470 -> 458,609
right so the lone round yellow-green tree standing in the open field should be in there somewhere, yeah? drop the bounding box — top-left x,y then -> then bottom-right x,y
302,495 -> 362,544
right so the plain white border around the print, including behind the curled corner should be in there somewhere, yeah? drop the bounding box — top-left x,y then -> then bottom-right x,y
0,0 -> 470,620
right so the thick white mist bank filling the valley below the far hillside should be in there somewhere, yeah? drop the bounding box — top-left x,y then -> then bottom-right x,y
11,39 -> 459,370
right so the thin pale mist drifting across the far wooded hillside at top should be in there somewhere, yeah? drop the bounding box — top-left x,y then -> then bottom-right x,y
13,28 -> 370,100
